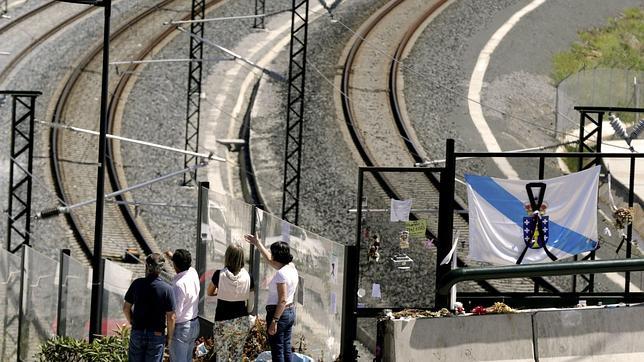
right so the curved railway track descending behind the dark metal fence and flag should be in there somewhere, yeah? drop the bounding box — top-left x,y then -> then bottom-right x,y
341,0 -> 557,293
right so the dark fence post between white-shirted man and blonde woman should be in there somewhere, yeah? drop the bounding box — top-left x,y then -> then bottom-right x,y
195,182 -> 210,315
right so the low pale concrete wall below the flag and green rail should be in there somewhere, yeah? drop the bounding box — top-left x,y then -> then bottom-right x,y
382,307 -> 644,362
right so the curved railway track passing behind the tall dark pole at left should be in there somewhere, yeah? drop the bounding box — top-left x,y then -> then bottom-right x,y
50,0 -> 220,261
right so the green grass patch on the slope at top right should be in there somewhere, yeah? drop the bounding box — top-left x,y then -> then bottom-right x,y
552,8 -> 644,84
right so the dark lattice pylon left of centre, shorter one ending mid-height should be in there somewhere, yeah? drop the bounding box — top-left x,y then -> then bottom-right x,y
183,0 -> 206,185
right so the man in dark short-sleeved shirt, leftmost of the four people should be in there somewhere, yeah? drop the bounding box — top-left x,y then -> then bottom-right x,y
123,253 -> 175,362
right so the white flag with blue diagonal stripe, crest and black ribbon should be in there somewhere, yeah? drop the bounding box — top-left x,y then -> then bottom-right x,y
465,166 -> 600,265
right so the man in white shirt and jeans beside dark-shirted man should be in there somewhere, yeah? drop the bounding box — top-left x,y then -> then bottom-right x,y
167,249 -> 201,362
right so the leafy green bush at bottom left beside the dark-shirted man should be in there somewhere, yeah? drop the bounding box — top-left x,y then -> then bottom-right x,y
36,327 -> 130,362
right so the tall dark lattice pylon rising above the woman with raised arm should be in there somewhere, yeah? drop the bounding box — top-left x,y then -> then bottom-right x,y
282,0 -> 309,224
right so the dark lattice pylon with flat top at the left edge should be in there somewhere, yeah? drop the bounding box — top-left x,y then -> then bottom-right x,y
0,91 -> 41,253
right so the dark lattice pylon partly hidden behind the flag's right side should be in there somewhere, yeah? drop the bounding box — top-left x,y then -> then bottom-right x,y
572,107 -> 605,293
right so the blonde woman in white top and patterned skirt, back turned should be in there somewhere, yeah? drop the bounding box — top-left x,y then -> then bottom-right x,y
208,244 -> 254,361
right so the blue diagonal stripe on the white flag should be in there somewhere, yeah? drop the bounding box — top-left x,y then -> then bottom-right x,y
465,175 -> 597,255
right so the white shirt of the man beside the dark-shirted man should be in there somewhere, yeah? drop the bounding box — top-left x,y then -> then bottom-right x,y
172,267 -> 201,323
